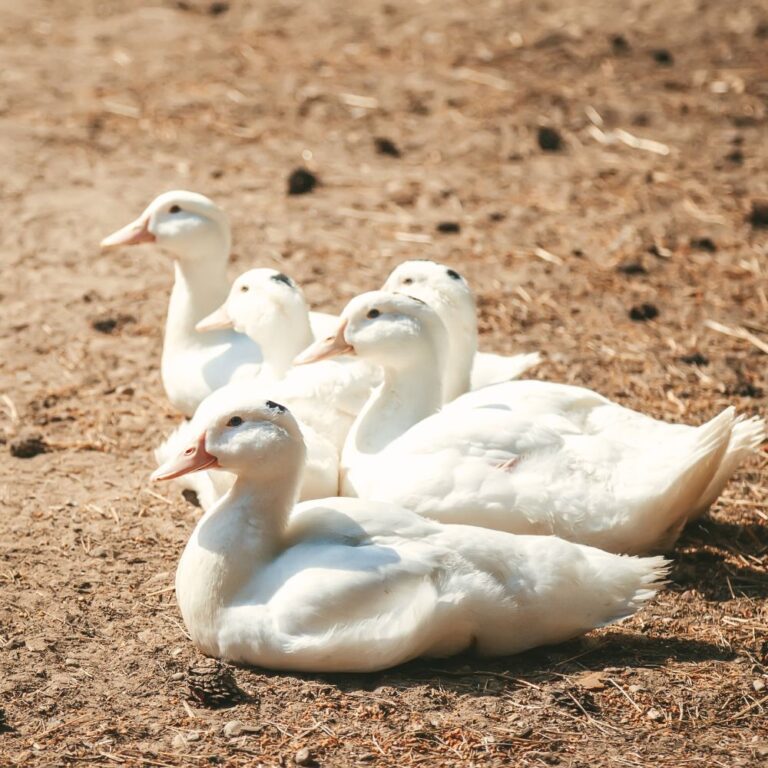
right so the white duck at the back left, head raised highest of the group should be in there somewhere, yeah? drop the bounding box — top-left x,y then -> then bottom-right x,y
101,195 -> 333,416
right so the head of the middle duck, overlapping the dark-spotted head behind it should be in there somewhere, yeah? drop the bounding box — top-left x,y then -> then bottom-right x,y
294,291 -> 447,370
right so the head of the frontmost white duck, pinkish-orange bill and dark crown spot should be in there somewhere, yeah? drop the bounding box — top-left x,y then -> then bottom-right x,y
152,384 -> 305,483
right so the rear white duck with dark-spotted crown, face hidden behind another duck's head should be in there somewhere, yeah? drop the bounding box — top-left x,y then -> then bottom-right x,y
382,259 -> 541,403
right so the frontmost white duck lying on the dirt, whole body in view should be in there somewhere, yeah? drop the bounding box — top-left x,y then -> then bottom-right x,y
154,391 -> 666,672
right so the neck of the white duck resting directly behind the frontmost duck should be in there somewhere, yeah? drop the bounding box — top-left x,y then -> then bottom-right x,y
344,349 -> 443,463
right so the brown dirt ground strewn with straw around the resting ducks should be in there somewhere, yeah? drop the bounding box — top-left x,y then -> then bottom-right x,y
0,0 -> 768,768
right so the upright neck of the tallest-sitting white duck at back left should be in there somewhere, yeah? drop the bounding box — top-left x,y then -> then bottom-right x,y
165,256 -> 229,349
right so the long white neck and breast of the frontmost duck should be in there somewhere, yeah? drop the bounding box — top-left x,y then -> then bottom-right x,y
176,472 -> 299,655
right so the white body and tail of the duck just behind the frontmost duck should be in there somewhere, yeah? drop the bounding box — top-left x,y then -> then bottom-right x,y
342,382 -> 734,553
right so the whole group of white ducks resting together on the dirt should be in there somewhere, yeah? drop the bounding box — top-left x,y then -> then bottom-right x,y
102,191 -> 766,672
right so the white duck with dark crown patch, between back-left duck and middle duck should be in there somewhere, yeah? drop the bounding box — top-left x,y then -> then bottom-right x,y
197,269 -> 381,451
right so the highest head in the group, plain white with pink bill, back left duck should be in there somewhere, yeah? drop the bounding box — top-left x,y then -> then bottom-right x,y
101,190 -> 231,261
